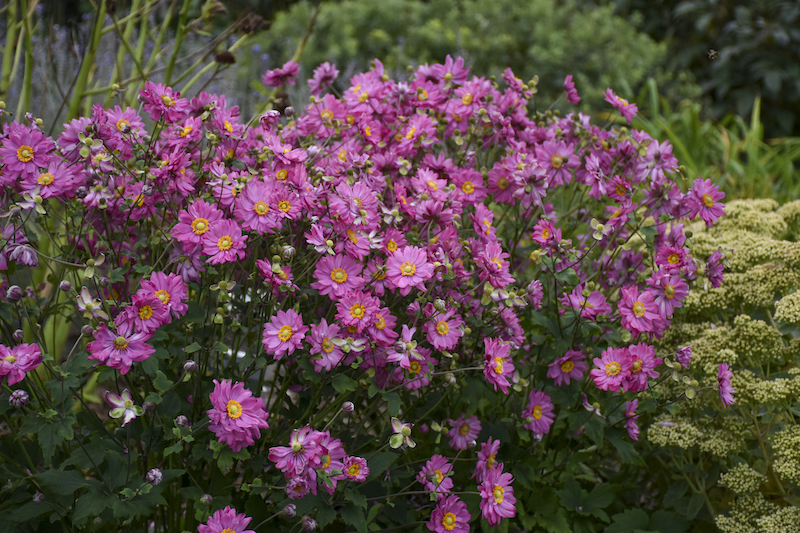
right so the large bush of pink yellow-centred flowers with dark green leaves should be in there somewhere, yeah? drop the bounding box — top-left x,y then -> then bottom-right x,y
0,56 -> 732,533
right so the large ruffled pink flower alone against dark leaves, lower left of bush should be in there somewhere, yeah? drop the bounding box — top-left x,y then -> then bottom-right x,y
206,379 -> 269,452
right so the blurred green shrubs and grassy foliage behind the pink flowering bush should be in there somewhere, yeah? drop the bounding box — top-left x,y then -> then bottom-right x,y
6,0 -> 800,201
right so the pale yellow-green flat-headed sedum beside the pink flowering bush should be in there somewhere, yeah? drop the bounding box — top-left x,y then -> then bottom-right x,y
647,199 -> 800,533
